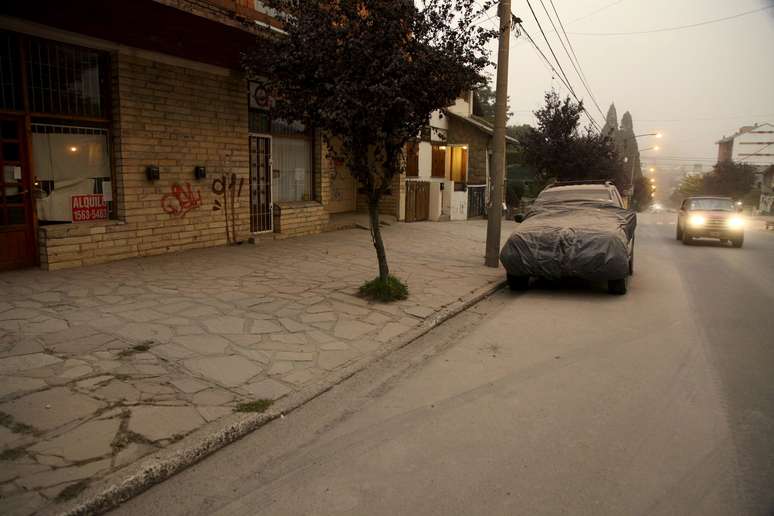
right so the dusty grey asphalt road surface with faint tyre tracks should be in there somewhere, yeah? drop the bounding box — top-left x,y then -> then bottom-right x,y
115,216 -> 774,515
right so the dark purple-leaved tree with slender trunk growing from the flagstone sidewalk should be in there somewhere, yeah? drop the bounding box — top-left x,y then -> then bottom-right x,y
244,0 -> 497,300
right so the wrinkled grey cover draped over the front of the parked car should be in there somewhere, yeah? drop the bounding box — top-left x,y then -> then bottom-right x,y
500,201 -> 637,281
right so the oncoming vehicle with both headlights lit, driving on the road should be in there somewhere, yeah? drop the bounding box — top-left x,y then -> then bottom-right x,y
676,197 -> 745,247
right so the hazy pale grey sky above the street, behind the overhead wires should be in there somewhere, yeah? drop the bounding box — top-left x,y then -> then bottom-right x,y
482,0 -> 774,173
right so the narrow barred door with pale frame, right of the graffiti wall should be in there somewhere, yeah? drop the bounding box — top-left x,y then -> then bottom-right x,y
250,136 -> 274,233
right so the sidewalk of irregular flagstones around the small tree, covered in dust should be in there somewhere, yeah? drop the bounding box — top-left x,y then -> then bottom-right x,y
0,221 -> 515,514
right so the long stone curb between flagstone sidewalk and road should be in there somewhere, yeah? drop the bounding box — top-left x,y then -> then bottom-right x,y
53,282 -> 505,516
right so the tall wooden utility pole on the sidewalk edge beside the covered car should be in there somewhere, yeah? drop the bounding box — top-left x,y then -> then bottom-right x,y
484,0 -> 511,267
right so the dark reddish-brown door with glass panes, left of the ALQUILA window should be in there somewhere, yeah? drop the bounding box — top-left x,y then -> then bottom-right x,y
0,117 -> 36,270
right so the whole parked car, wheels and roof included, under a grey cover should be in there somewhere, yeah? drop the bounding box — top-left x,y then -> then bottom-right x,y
500,182 -> 637,294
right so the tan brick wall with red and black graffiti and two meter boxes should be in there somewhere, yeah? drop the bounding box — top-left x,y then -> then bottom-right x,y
39,52 -> 250,269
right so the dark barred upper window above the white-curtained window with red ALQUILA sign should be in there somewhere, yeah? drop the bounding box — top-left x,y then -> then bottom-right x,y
26,38 -> 107,118
